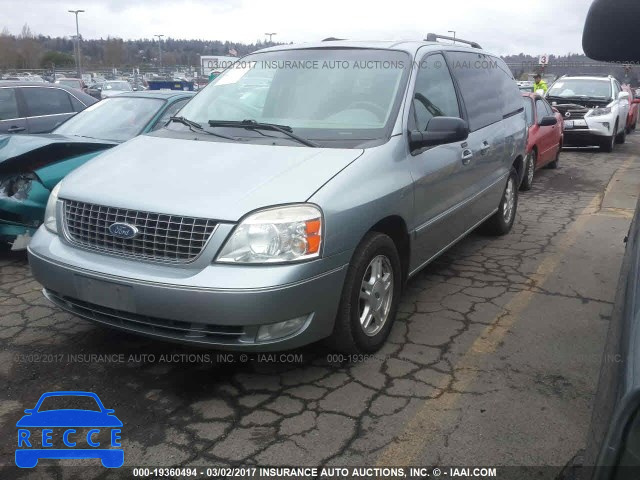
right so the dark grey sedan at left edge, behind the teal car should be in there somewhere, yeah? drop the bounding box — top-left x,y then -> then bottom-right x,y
0,81 -> 97,134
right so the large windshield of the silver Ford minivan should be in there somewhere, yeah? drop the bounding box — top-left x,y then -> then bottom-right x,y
174,48 -> 410,145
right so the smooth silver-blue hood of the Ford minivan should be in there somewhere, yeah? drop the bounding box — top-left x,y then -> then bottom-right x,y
60,135 -> 363,221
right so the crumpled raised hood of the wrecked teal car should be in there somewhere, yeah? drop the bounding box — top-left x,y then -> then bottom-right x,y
0,134 -> 116,174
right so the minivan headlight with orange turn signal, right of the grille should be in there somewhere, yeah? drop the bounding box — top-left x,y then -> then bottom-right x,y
217,204 -> 323,263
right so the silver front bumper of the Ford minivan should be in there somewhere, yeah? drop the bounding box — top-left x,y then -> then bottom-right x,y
28,227 -> 350,351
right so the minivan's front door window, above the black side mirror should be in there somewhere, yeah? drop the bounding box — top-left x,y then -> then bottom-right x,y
413,54 -> 460,130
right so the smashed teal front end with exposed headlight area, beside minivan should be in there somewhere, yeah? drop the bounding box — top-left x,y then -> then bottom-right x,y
0,172 -> 51,250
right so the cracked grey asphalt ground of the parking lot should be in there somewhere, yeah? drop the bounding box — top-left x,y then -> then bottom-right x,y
0,134 -> 640,478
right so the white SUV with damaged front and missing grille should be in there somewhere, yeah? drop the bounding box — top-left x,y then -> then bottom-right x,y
546,75 -> 629,152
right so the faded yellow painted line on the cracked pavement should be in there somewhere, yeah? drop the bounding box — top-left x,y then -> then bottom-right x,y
377,156 -> 634,466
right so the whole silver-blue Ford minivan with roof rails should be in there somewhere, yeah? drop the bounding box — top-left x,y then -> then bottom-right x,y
29,36 -> 527,352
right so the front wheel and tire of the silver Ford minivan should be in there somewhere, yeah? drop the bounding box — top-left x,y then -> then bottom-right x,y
327,232 -> 402,353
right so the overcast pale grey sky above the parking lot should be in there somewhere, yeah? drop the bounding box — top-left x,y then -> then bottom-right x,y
0,0 -> 591,55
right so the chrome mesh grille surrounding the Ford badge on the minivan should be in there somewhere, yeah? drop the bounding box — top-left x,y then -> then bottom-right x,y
64,200 -> 217,263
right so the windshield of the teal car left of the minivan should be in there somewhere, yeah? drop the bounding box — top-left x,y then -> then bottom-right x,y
53,96 -> 164,142
